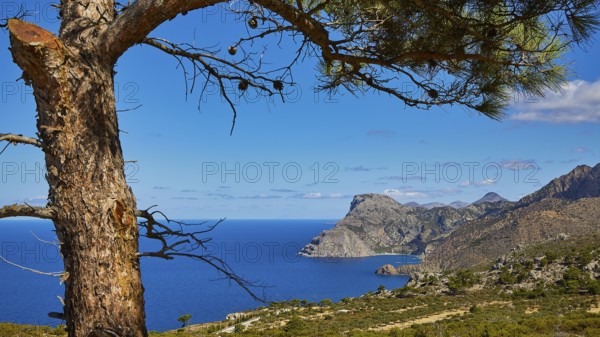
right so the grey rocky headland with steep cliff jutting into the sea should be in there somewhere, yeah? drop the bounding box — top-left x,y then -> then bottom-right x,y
301,194 -> 513,257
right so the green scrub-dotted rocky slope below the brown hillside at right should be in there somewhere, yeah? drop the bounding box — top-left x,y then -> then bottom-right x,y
400,234 -> 600,298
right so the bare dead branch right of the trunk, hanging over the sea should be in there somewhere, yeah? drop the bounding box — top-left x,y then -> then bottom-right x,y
136,206 -> 266,302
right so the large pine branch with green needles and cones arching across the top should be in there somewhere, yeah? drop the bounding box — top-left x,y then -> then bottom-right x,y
99,0 -> 600,118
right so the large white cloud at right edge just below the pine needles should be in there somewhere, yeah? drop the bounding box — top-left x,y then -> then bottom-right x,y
510,80 -> 600,124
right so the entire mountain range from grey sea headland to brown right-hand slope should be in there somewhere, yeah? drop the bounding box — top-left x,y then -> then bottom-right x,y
301,164 -> 600,269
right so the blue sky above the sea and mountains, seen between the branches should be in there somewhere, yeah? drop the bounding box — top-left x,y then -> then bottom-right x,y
0,1 -> 600,219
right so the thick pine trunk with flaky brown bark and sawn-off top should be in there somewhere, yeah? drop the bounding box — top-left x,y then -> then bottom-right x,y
9,19 -> 147,337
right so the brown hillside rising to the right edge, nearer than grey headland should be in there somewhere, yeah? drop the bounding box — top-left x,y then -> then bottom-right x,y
426,164 -> 600,269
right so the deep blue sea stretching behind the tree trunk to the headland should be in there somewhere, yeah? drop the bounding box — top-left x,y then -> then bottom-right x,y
0,220 -> 418,331
